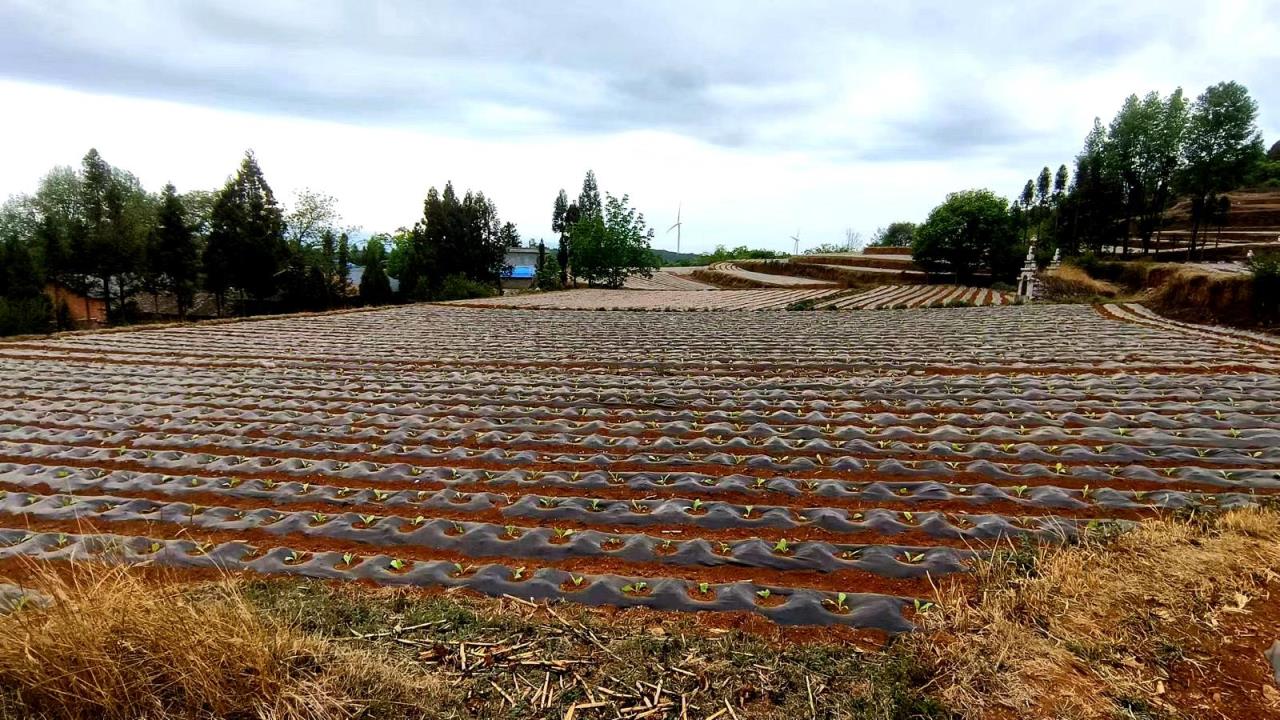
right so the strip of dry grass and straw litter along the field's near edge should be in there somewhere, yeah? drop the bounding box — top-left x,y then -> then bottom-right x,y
0,510 -> 1280,720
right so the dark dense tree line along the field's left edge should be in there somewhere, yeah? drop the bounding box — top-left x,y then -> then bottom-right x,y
0,150 -> 535,334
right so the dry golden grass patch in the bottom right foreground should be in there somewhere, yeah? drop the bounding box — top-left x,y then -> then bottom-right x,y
908,510 -> 1280,719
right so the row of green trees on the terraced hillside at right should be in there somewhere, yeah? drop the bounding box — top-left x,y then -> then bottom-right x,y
870,82 -> 1280,282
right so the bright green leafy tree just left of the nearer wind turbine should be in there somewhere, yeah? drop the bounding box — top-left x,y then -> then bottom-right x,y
570,193 -> 660,288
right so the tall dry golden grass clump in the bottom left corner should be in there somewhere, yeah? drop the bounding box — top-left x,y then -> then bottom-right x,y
0,565 -> 447,720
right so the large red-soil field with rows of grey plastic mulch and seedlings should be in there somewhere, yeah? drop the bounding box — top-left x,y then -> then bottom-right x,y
0,305 -> 1280,633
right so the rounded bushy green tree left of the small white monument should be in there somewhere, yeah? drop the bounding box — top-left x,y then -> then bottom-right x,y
911,190 -> 1019,283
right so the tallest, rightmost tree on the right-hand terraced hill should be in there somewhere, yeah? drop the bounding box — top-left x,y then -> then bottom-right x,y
1181,82 -> 1263,255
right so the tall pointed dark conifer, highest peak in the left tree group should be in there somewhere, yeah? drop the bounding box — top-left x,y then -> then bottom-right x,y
205,151 -> 288,311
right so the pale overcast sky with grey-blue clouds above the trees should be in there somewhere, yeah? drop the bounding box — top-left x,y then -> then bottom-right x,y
0,0 -> 1280,250
